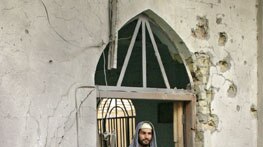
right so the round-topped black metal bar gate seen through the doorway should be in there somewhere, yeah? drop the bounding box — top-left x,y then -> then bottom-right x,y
97,98 -> 136,147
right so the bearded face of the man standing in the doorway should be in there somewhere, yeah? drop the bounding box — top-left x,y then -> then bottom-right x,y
139,129 -> 152,147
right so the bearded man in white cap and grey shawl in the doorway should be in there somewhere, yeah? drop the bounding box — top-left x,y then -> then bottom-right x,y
129,121 -> 157,147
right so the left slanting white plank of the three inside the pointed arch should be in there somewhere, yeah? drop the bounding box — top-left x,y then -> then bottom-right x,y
117,19 -> 142,87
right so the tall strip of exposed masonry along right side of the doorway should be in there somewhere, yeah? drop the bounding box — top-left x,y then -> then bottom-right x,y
187,52 -> 219,147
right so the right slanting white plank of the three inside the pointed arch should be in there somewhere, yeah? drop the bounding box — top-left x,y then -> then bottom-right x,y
146,21 -> 170,89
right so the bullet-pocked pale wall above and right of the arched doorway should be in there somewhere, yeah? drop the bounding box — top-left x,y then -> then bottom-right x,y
119,0 -> 257,147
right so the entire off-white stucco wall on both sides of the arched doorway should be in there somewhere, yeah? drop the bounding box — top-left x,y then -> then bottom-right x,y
0,0 -> 262,147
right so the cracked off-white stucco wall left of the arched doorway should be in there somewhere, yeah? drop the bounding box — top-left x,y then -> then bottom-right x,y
0,0 -> 108,147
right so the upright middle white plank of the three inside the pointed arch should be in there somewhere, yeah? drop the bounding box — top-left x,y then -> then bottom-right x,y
142,20 -> 147,88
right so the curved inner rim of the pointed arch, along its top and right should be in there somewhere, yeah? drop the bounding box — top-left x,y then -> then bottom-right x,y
110,9 -> 194,87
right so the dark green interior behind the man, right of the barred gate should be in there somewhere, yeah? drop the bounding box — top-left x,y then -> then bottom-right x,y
132,100 -> 174,147
